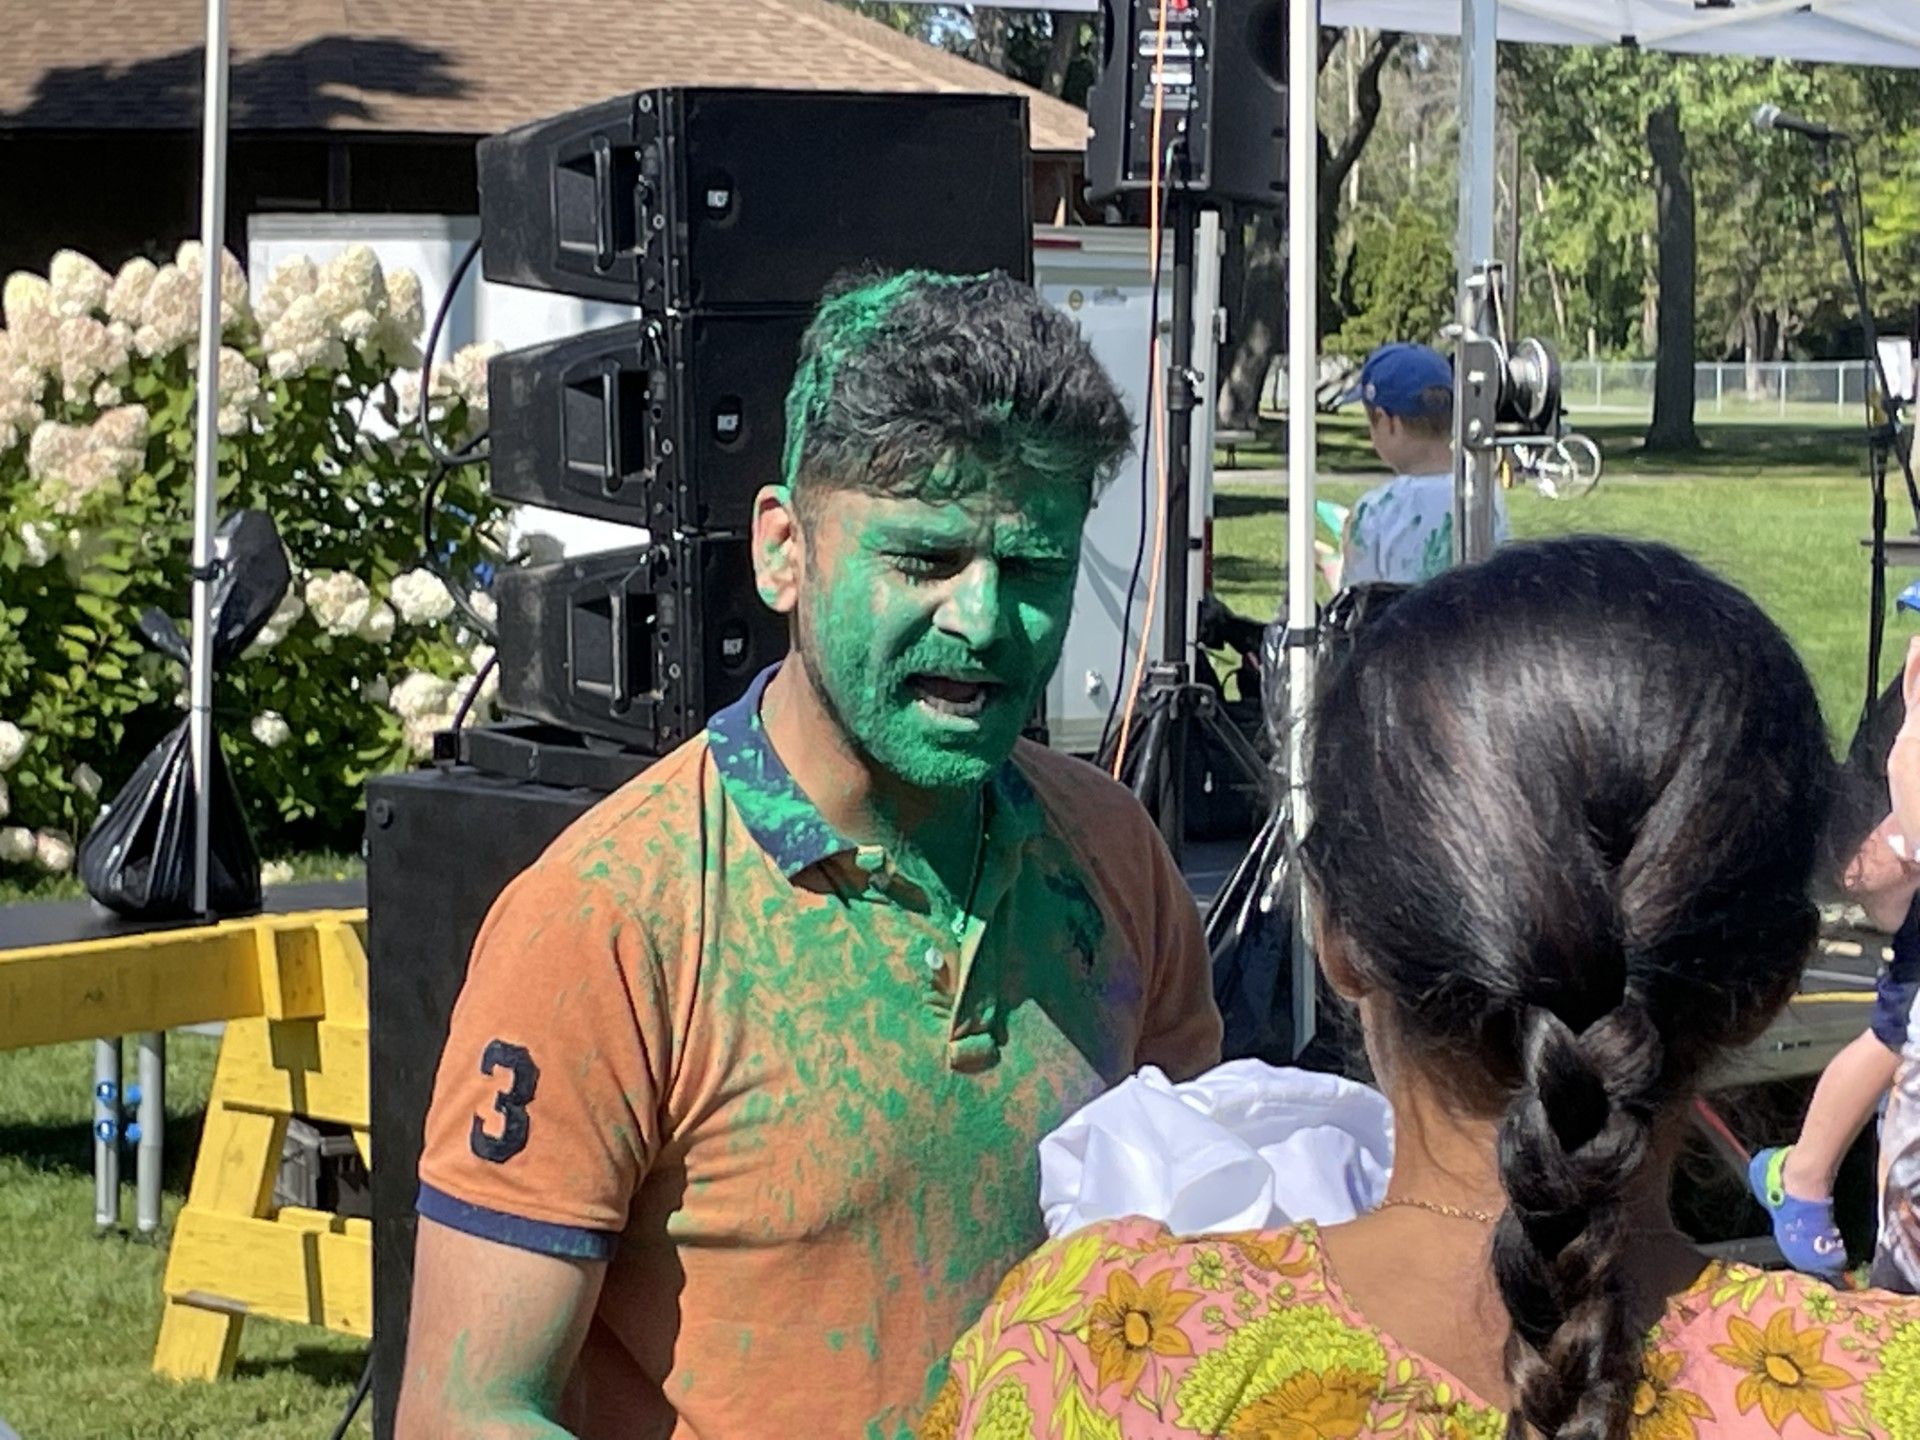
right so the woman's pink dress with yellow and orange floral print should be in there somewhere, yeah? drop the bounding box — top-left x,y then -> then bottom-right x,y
920,1219 -> 1920,1440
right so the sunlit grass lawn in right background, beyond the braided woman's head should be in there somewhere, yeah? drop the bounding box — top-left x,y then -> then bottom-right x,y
1213,419 -> 1889,743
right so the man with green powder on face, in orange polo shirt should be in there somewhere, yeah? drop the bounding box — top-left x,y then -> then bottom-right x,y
399,273 -> 1219,1440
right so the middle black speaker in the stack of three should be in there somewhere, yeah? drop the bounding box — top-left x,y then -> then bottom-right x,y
488,311 -> 806,534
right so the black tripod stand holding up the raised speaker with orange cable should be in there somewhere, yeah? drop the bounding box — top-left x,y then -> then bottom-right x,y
1100,190 -> 1271,860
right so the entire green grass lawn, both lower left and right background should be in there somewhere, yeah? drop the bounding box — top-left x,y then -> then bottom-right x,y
0,419 -> 1910,1440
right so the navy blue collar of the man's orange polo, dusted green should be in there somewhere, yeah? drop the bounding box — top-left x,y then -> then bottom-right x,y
707,662 -> 1043,879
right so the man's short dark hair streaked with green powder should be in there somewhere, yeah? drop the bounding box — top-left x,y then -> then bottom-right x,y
781,271 -> 1133,507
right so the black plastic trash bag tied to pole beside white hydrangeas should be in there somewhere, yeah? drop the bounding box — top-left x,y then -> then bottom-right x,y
79,511 -> 292,920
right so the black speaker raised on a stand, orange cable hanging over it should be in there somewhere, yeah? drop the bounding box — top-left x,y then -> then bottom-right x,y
1087,0 -> 1288,207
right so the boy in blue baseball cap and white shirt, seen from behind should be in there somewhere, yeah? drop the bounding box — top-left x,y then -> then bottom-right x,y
1340,342 -> 1507,586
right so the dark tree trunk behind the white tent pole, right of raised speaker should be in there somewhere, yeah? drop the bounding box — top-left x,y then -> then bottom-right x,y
1215,29 -> 1400,430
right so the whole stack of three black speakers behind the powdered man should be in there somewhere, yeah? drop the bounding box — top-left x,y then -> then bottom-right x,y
480,88 -> 1033,755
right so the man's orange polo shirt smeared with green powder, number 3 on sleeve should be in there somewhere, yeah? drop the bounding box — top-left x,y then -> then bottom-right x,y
419,676 -> 1221,1440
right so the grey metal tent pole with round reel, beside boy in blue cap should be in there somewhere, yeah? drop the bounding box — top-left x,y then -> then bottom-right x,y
1453,0 -> 1500,561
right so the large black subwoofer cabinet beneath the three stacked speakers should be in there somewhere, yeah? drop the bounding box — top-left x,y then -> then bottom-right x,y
367,766 -> 601,1440
